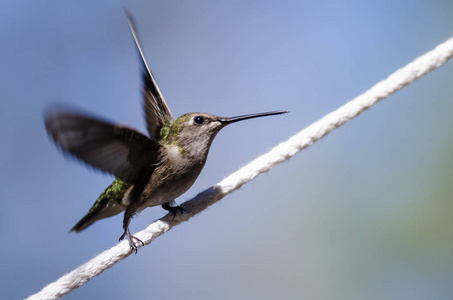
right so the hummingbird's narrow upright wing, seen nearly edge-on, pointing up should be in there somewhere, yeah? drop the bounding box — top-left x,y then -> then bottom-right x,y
125,10 -> 173,141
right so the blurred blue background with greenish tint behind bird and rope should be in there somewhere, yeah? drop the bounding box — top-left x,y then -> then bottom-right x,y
0,0 -> 453,299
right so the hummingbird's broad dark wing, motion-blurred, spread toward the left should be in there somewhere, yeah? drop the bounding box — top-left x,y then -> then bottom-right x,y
44,110 -> 161,183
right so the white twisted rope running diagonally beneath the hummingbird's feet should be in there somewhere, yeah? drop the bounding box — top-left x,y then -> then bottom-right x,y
28,37 -> 453,299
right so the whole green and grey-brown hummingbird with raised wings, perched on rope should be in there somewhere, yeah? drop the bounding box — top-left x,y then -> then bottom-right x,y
44,11 -> 287,253
